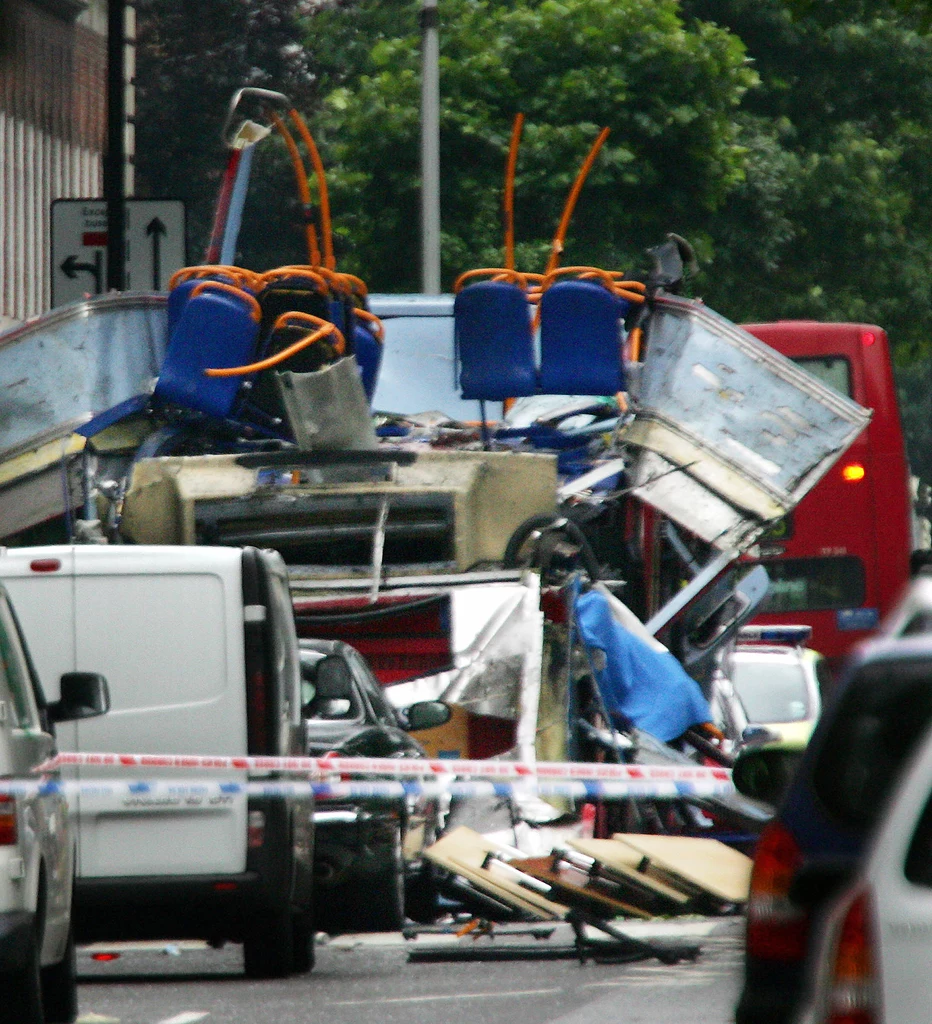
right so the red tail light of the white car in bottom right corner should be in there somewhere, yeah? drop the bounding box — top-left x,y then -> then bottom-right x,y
824,891 -> 880,1024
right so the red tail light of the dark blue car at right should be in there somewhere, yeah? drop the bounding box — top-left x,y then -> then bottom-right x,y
748,821 -> 809,962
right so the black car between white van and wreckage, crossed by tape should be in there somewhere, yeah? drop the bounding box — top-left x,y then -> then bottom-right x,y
301,640 -> 450,934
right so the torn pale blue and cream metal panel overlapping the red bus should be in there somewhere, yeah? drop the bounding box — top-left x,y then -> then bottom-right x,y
623,295 -> 871,548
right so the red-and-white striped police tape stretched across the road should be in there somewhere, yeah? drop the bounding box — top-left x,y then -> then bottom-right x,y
39,752 -> 731,791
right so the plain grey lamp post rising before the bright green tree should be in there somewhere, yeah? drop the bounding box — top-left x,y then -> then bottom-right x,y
421,0 -> 440,295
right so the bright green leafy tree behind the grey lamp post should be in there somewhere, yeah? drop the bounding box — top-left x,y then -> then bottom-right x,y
308,0 -> 756,291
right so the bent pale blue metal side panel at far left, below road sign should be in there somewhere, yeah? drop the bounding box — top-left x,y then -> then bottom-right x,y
0,293 -> 168,459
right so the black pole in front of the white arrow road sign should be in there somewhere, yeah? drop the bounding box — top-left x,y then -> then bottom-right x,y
103,0 -> 126,292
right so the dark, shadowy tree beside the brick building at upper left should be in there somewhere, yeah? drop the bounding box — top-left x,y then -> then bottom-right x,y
136,0 -> 313,268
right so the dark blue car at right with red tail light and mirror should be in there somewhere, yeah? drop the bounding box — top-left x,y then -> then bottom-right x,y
734,630 -> 932,1024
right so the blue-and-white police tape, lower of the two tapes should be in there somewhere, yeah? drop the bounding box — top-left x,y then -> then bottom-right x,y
0,776 -> 734,813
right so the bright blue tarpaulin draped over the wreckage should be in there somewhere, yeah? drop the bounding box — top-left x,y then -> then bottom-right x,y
576,590 -> 712,743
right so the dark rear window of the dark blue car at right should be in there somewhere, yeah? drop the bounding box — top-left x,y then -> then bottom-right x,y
812,659 -> 932,828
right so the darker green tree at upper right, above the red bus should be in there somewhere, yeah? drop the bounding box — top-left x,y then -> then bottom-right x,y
683,0 -> 932,352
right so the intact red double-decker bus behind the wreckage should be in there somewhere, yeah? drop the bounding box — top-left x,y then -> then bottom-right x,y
744,321 -> 914,668
